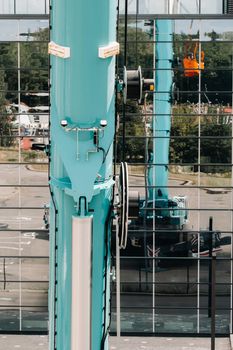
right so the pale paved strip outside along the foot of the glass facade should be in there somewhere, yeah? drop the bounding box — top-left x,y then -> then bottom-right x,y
0,335 -> 231,350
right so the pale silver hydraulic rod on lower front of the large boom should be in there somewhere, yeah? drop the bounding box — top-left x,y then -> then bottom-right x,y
71,216 -> 93,350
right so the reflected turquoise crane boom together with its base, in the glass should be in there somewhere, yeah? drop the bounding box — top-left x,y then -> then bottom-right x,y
148,20 -> 187,229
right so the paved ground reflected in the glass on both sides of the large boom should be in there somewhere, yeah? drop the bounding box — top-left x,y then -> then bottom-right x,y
0,164 -> 232,334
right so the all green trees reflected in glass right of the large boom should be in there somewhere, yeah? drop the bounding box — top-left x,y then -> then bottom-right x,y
118,22 -> 233,167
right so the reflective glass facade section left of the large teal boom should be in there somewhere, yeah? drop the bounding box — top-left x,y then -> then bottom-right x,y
0,0 -> 49,332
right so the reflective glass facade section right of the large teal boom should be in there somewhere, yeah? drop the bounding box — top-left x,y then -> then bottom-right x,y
112,0 -> 233,335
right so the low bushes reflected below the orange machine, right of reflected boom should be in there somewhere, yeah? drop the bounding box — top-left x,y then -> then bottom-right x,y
170,105 -> 231,172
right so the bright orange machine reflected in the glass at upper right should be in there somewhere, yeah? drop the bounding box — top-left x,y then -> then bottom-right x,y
183,43 -> 205,77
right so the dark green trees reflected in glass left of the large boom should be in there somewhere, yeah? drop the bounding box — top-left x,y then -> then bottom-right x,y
0,28 -> 49,147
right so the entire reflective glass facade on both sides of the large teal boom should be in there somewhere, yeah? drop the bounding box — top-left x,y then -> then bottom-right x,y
0,0 -> 233,334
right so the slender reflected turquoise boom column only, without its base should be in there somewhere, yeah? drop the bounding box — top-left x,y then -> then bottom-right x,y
149,20 -> 173,200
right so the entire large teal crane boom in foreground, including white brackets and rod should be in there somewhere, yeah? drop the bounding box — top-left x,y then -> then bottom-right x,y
49,0 -> 118,350
